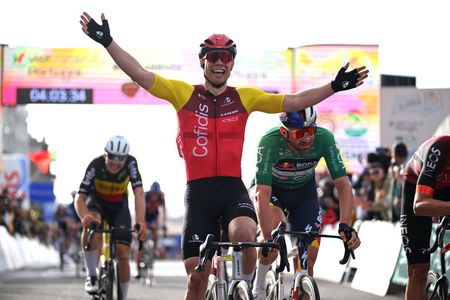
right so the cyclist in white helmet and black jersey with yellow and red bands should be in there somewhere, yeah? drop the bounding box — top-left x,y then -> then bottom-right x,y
75,135 -> 147,300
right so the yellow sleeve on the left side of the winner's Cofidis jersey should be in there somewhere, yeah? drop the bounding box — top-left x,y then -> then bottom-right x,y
148,74 -> 194,112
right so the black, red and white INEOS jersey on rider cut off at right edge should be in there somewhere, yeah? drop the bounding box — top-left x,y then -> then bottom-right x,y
403,135 -> 450,200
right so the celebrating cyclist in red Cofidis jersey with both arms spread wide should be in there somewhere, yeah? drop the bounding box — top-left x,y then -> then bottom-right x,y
80,13 -> 369,299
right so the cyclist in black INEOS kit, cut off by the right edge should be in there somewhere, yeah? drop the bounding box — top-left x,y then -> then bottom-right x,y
400,135 -> 450,300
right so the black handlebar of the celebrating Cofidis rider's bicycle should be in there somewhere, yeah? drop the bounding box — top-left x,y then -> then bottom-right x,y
195,223 -> 290,272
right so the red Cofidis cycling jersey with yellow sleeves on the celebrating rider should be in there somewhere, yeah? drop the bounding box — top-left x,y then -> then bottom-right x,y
149,75 -> 284,181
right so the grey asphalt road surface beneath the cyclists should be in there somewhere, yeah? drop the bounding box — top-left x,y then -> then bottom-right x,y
0,261 -> 404,300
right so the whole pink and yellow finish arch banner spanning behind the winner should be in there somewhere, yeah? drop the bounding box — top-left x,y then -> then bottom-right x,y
3,45 -> 380,172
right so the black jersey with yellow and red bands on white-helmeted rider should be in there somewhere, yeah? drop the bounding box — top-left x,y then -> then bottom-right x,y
79,155 -> 142,203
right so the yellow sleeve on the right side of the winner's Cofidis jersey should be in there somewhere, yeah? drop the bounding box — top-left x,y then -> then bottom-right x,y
236,87 -> 285,113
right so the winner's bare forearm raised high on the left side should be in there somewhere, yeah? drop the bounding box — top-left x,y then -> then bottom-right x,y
106,41 -> 155,90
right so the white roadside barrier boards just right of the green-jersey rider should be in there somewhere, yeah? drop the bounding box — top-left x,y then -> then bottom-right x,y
314,221 -> 407,297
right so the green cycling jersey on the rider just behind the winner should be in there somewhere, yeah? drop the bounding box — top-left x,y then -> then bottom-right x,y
255,127 -> 347,189
